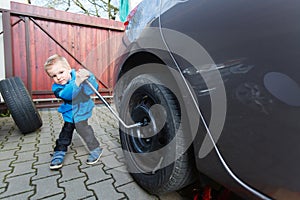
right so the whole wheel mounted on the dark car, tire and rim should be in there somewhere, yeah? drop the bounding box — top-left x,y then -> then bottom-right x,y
120,75 -> 196,194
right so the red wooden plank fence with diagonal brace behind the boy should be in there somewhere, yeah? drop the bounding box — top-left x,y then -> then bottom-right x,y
3,2 -> 124,104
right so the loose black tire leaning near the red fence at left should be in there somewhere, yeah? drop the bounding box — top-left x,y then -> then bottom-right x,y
0,77 -> 43,134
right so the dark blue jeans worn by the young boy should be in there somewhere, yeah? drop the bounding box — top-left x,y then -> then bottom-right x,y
54,120 -> 100,151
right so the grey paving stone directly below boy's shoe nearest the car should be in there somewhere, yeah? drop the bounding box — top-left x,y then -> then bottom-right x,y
82,164 -> 112,185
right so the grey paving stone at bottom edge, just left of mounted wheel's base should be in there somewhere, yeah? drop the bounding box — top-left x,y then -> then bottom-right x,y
117,182 -> 159,200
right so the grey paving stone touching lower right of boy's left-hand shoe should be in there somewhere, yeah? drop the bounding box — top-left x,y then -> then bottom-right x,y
59,163 -> 87,183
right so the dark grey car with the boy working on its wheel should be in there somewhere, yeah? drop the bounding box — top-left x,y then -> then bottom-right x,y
114,0 -> 300,199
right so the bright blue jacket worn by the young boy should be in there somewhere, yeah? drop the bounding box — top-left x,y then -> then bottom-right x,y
52,69 -> 98,123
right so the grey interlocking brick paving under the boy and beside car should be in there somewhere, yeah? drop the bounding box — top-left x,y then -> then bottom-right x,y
0,105 -> 183,200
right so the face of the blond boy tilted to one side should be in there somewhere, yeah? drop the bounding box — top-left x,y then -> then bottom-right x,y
47,62 -> 71,85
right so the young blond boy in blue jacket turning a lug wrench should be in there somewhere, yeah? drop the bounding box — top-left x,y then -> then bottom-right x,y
44,54 -> 103,169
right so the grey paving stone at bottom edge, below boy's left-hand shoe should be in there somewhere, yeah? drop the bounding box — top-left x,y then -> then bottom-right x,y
31,175 -> 64,199
